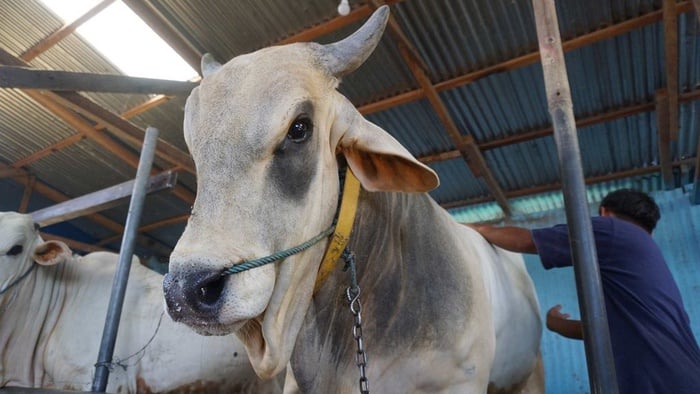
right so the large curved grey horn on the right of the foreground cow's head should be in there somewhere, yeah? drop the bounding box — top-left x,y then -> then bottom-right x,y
323,5 -> 389,77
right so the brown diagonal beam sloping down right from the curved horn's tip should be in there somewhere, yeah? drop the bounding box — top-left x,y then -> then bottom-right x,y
371,0 -> 511,216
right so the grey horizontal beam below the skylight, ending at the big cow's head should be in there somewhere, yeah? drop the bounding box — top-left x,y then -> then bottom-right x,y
0,66 -> 199,96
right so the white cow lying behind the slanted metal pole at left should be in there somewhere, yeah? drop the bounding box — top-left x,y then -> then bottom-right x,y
0,212 -> 282,393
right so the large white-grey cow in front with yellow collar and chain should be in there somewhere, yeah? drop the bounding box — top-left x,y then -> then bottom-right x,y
164,7 -> 543,394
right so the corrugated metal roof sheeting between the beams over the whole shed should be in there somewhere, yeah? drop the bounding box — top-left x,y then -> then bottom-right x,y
0,0 -> 700,260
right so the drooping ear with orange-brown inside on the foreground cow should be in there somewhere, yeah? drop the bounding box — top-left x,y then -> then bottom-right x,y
336,105 -> 440,192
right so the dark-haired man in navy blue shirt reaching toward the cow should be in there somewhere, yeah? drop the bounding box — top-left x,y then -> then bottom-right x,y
471,189 -> 700,394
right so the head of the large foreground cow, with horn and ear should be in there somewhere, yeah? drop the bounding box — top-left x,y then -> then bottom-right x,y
164,7 -> 438,377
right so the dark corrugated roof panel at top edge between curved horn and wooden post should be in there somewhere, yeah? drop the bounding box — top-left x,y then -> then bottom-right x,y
395,0 -> 537,81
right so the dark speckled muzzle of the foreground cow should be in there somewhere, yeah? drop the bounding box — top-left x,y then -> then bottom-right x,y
163,271 -> 228,324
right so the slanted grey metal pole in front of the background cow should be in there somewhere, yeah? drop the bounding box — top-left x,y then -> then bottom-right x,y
92,127 -> 158,392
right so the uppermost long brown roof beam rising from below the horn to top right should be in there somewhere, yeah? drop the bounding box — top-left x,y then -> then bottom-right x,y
358,0 -> 698,115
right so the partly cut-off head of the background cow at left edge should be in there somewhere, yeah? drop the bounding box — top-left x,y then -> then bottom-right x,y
0,212 -> 72,291
